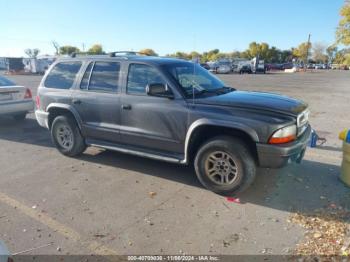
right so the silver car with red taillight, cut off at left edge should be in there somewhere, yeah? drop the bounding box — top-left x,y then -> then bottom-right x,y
0,76 -> 34,120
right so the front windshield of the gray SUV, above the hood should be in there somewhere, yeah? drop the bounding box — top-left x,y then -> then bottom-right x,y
166,63 -> 233,97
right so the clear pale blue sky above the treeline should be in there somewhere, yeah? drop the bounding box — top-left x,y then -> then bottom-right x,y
0,0 -> 344,56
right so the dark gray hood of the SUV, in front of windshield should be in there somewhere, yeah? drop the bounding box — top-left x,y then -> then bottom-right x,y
195,91 -> 308,116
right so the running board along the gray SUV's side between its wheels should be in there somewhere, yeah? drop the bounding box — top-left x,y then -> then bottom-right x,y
86,140 -> 185,164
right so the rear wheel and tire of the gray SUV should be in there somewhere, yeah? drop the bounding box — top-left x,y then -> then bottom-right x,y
51,116 -> 86,157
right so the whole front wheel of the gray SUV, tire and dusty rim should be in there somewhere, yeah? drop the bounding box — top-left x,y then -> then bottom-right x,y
194,136 -> 256,196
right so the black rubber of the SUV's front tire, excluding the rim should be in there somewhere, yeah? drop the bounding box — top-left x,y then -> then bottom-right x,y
194,136 -> 256,196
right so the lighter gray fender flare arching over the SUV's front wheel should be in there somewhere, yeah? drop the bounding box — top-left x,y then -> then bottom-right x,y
181,118 -> 259,164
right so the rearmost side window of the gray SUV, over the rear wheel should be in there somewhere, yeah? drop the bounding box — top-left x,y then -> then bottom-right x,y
44,62 -> 81,89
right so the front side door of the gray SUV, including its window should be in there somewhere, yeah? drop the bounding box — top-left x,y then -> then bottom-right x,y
120,63 -> 188,154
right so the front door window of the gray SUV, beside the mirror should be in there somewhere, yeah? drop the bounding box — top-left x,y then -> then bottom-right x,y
126,64 -> 166,95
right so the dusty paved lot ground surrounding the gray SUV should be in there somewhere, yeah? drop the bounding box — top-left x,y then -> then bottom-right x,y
0,71 -> 350,254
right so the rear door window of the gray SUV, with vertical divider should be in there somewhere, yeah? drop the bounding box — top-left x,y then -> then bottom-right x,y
80,62 -> 120,92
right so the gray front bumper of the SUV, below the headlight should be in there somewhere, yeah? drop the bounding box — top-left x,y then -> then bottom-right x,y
256,126 -> 311,168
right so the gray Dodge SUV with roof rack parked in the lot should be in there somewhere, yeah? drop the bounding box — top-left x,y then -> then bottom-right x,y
35,53 -> 311,195
